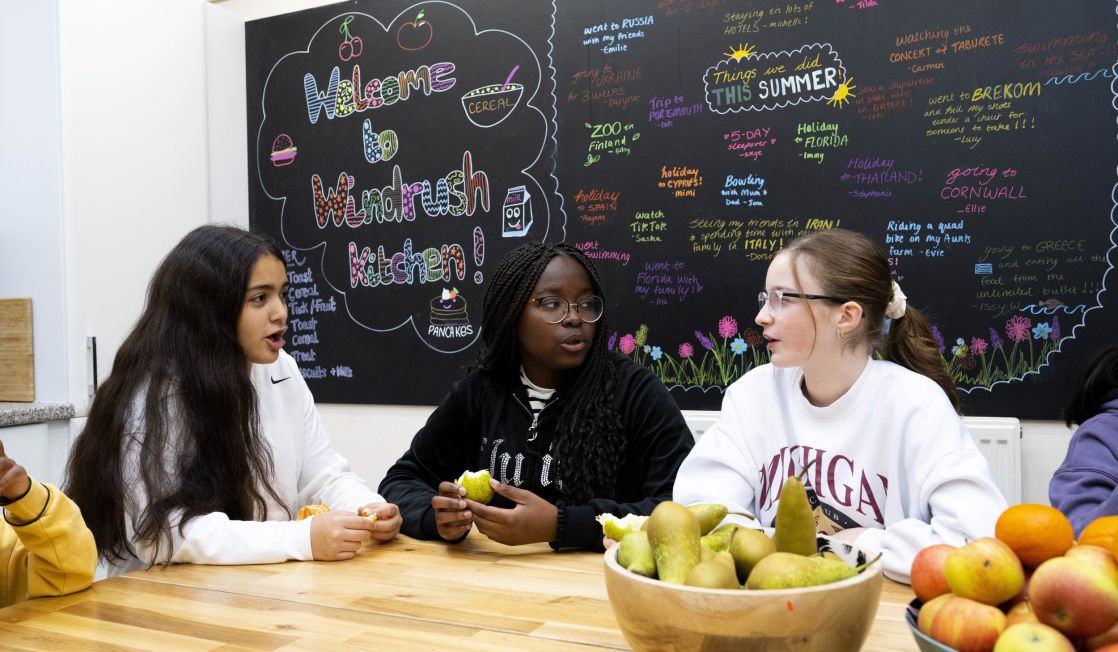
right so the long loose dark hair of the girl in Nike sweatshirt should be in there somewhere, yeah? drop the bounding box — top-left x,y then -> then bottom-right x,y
65,225 -> 283,561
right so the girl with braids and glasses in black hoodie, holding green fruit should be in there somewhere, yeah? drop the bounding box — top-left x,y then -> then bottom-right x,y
379,242 -> 692,549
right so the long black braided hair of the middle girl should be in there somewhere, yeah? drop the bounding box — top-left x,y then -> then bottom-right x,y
476,242 -> 625,504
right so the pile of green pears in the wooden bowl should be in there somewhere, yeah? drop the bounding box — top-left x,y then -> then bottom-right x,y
617,476 -> 866,589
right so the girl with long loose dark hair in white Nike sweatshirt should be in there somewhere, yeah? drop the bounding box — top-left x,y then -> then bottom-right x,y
66,226 -> 400,574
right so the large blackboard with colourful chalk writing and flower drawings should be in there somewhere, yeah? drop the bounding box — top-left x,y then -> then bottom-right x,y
245,0 -> 1118,418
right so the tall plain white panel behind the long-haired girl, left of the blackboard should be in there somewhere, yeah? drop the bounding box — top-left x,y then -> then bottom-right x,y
57,0 -> 209,414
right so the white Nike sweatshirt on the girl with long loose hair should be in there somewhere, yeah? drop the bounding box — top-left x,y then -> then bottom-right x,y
108,351 -> 385,575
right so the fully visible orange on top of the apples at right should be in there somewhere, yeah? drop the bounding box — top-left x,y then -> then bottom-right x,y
994,503 -> 1076,568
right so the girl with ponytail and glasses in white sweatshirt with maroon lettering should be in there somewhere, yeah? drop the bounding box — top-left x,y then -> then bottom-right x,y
674,229 -> 1006,582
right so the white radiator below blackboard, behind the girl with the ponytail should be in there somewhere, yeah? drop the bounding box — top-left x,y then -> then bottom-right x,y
683,409 -> 1021,504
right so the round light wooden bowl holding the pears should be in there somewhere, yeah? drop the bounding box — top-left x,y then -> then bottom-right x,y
604,537 -> 883,652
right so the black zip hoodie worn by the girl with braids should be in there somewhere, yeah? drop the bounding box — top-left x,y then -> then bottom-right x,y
379,353 -> 694,550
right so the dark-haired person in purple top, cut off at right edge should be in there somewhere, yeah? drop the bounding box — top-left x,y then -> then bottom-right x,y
1049,344 -> 1118,537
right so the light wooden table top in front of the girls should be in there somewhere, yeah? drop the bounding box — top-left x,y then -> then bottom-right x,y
0,530 -> 917,651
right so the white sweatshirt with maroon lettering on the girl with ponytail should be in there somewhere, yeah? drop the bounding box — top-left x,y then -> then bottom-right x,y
673,360 -> 1006,582
